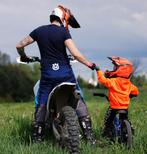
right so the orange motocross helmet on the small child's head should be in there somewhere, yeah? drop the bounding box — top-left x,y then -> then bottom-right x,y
105,56 -> 133,79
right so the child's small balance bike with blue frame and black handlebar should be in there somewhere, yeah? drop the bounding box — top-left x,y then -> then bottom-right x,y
93,93 -> 134,148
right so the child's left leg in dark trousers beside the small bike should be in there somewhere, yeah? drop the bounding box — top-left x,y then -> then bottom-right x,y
103,107 -> 117,137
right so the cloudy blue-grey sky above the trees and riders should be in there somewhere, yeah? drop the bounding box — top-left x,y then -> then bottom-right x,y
0,0 -> 147,79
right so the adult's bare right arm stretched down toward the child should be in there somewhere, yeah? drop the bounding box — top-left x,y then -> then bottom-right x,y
65,39 -> 93,68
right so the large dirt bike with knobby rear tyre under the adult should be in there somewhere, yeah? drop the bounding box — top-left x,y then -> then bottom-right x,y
17,57 -> 80,154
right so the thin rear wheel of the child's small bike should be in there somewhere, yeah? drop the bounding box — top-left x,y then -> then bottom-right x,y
121,120 -> 133,148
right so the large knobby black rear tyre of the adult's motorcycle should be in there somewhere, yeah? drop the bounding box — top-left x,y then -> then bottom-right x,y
55,106 -> 80,154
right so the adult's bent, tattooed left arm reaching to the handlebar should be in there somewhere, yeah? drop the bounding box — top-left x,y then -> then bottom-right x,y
16,36 -> 34,57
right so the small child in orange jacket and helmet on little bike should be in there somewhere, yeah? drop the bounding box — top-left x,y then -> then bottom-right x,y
96,56 -> 139,137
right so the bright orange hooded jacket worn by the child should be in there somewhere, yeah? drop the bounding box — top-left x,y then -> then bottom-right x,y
97,70 -> 139,109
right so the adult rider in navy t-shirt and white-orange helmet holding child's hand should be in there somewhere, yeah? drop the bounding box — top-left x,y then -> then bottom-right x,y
16,5 -> 96,144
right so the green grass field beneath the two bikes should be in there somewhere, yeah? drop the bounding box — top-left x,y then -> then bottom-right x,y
0,88 -> 147,154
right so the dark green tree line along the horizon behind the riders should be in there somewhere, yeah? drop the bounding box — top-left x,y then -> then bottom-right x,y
0,52 -> 147,102
